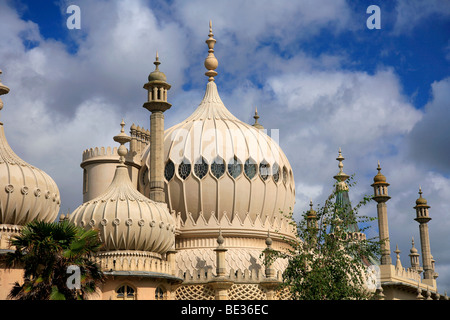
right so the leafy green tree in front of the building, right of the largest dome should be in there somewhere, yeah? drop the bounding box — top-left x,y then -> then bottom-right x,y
270,176 -> 381,300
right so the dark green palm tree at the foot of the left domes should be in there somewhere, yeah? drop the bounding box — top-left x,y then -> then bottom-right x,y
7,220 -> 104,300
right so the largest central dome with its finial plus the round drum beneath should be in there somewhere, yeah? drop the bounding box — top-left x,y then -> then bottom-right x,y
139,25 -> 295,272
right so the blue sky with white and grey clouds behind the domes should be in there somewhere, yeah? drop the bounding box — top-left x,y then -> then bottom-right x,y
0,0 -> 450,292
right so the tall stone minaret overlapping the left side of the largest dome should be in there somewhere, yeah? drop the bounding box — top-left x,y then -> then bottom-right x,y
143,52 -> 172,202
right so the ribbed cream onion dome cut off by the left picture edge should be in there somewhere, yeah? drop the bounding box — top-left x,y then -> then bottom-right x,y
0,71 -> 60,225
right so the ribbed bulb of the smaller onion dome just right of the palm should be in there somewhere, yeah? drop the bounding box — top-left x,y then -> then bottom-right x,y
69,165 -> 175,254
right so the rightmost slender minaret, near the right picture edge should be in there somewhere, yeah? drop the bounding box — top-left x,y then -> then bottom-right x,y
414,188 -> 434,279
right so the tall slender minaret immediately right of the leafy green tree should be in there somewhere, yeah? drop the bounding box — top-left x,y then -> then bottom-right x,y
371,161 -> 392,265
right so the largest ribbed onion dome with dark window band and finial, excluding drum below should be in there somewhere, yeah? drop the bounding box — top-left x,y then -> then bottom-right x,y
139,25 -> 295,230
